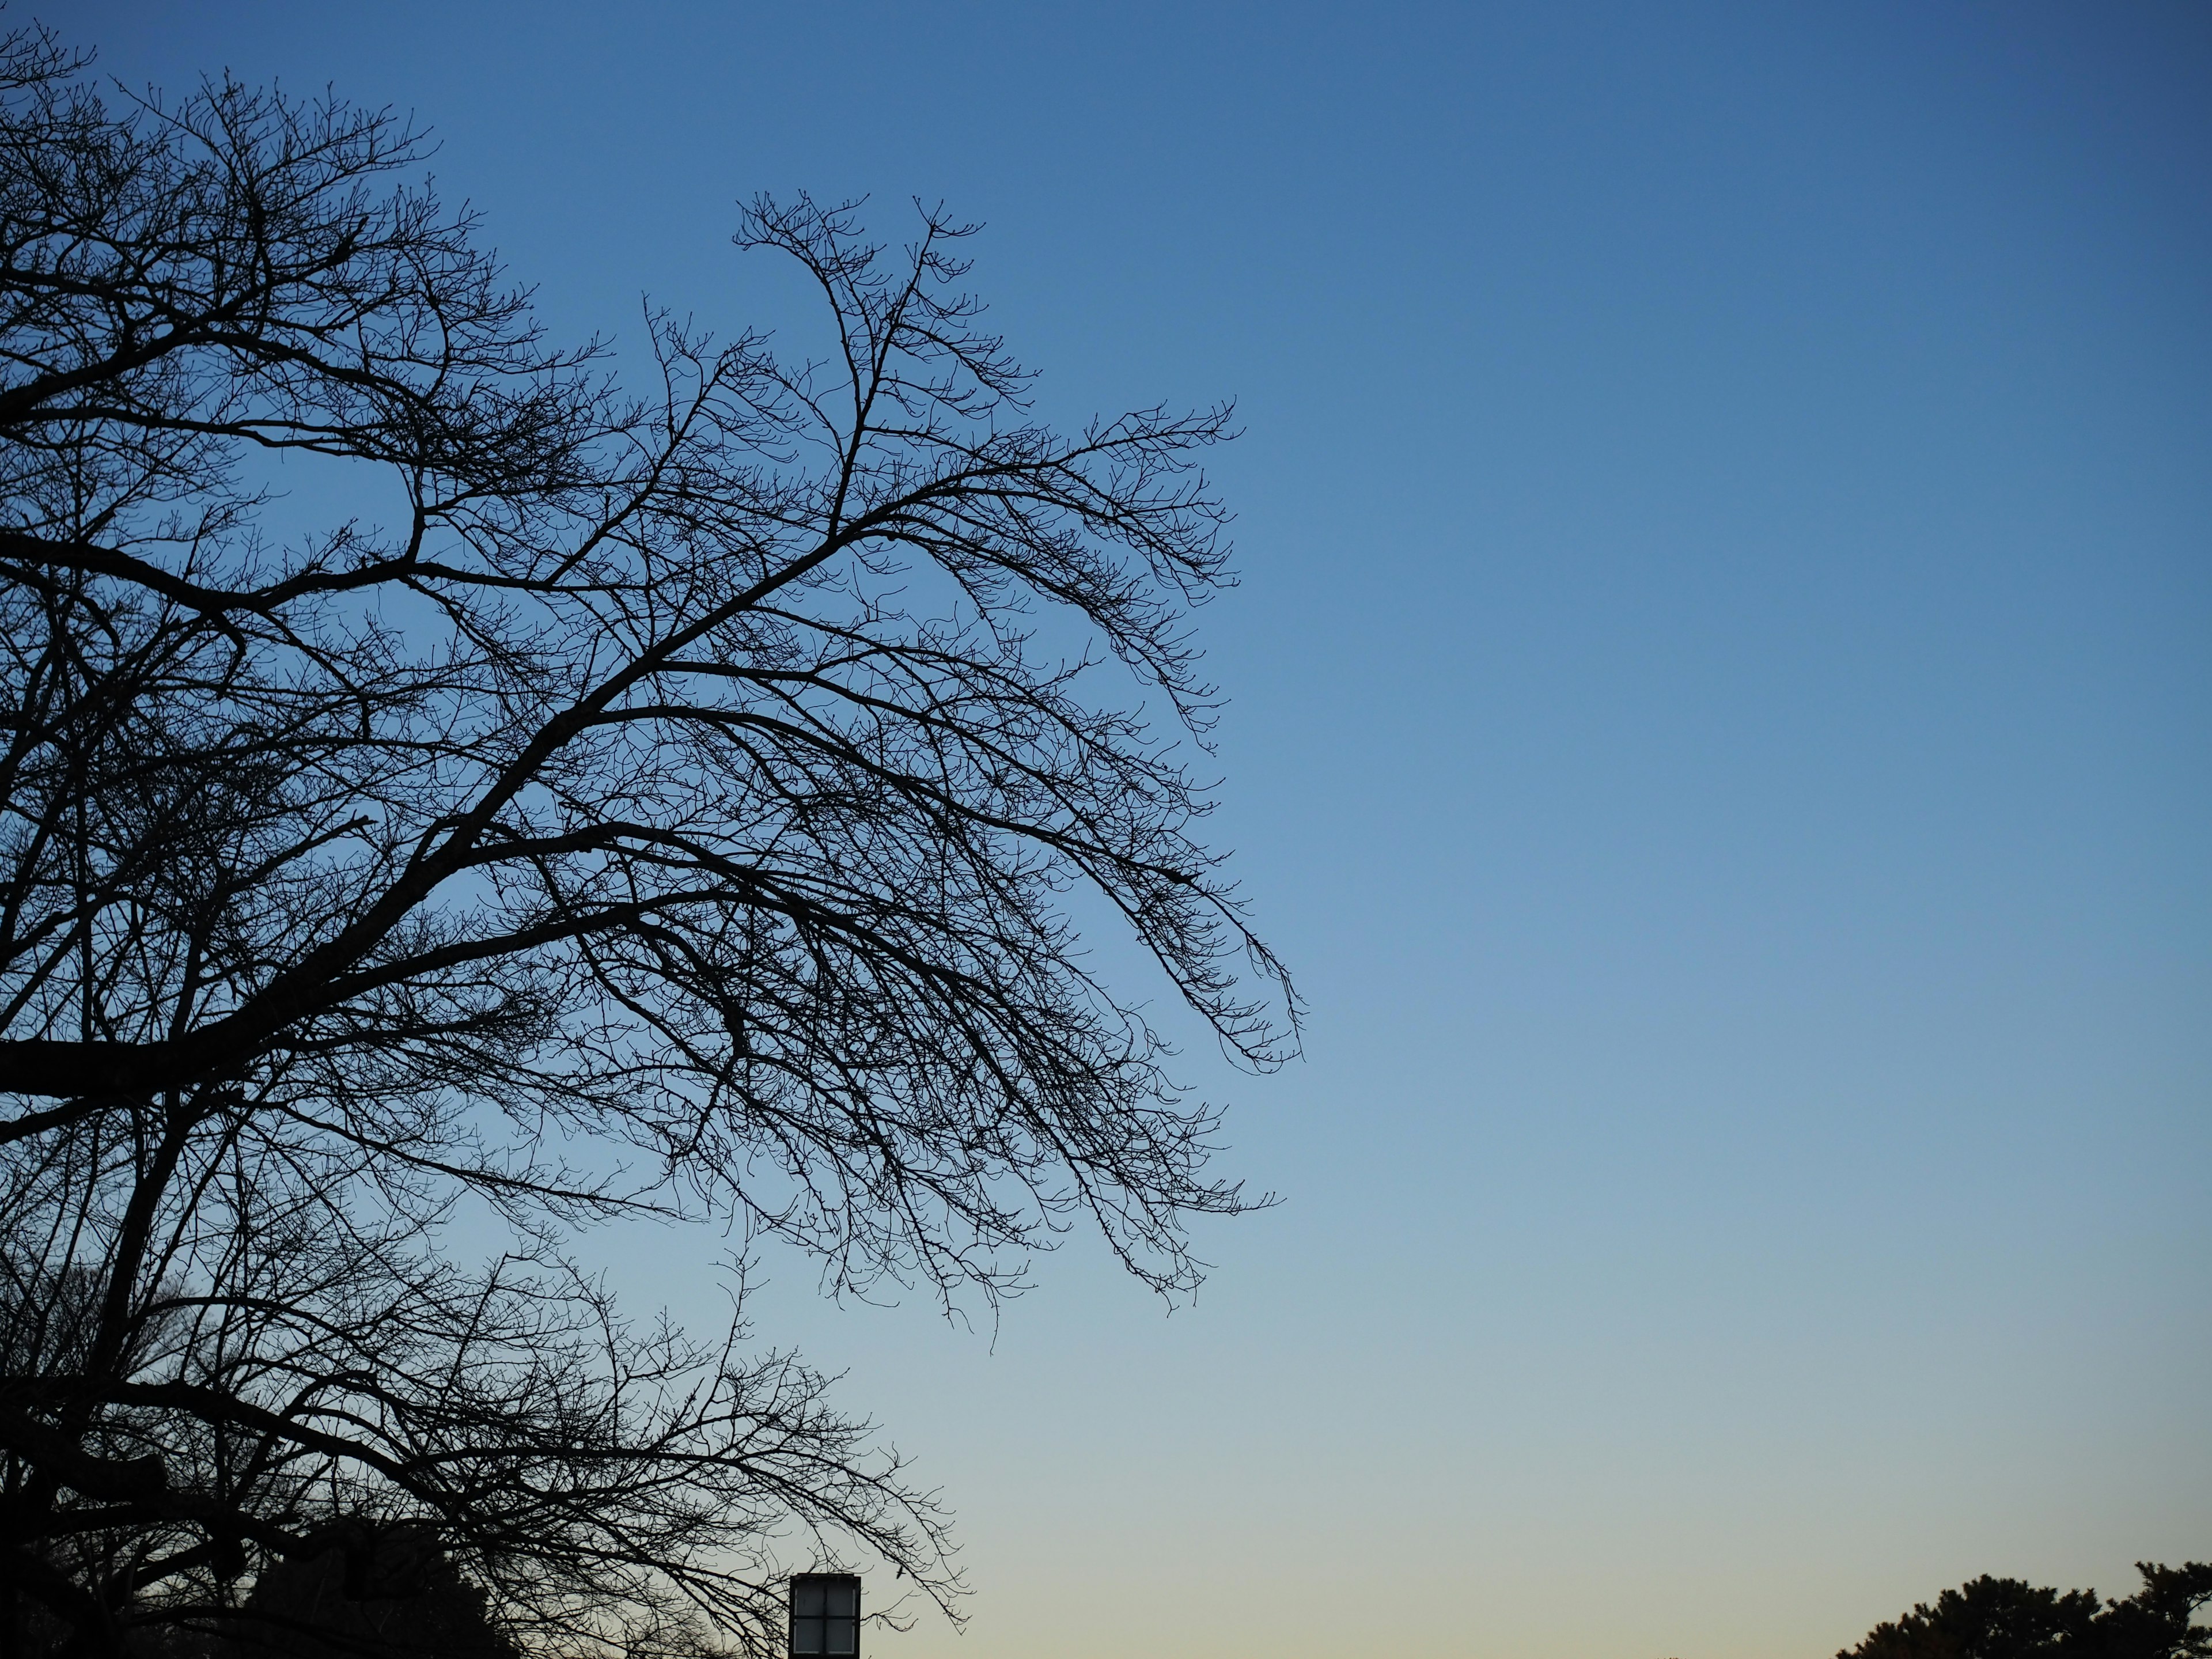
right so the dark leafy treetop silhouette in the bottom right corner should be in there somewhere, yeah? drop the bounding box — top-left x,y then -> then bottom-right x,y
1836,1562 -> 2212,1659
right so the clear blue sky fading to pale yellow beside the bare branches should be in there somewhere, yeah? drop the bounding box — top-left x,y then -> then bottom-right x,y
52,0 -> 2212,1659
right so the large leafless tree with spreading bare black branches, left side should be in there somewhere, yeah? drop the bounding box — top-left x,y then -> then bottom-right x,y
0,31 -> 1290,1654
